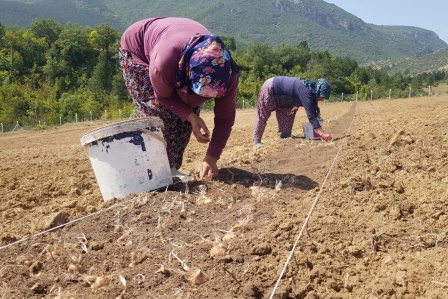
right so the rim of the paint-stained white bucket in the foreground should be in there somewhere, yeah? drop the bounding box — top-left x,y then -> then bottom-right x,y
80,116 -> 164,146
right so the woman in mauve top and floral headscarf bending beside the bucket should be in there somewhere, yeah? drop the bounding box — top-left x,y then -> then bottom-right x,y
119,17 -> 238,178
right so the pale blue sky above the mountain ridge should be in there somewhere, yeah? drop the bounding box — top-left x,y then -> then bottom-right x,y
324,0 -> 448,43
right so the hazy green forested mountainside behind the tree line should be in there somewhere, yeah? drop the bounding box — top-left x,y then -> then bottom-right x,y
0,0 -> 448,63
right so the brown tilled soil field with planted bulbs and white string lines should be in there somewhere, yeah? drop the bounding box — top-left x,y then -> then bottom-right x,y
0,96 -> 448,299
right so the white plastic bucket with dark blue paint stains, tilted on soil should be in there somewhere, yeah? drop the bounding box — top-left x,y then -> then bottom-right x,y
81,117 -> 173,201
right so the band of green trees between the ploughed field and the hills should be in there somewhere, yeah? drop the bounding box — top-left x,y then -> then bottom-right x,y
0,19 -> 448,130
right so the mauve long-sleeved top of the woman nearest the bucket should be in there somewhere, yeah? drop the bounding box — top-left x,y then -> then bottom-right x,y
120,17 -> 238,159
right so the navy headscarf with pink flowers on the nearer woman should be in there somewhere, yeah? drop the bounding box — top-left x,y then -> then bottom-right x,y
177,34 -> 232,98
